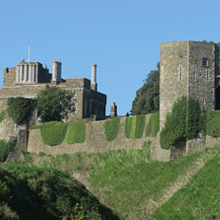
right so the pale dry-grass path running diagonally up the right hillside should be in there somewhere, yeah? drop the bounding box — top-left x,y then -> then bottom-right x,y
144,145 -> 219,219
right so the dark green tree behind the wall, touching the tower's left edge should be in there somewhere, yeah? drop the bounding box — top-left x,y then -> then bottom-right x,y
131,63 -> 160,115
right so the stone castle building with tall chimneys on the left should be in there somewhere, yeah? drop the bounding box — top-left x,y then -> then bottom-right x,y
0,60 -> 106,120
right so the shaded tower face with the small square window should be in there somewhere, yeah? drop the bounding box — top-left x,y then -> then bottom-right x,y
188,42 -> 215,111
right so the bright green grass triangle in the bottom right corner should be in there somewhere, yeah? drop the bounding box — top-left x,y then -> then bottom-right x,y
154,149 -> 220,220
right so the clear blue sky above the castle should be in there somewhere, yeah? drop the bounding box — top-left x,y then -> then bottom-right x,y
0,0 -> 220,115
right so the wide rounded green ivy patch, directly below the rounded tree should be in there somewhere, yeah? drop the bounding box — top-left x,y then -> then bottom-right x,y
39,122 -> 67,146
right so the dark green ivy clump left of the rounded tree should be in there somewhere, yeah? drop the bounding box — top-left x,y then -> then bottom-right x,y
8,97 -> 37,125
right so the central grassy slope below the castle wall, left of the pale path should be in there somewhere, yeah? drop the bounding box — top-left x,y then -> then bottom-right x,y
24,145 -> 219,219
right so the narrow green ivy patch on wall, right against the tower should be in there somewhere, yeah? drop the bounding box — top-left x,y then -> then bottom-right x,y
146,112 -> 159,137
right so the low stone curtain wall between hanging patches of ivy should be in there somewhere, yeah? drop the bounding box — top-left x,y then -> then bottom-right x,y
28,115 -> 163,156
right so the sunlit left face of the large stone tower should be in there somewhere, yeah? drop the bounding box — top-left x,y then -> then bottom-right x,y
160,42 -> 189,130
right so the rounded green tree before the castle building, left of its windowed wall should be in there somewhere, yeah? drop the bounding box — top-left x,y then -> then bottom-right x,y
37,86 -> 74,122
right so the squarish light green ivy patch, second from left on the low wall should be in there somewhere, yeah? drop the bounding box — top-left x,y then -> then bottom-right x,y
65,121 -> 86,144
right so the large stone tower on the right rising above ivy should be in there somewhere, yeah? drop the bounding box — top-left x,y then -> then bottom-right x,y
160,41 -> 220,129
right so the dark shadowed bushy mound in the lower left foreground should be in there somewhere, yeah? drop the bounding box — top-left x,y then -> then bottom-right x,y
0,164 -> 118,220
